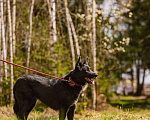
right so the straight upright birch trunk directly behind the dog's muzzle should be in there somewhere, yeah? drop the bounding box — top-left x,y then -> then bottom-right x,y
86,0 -> 96,109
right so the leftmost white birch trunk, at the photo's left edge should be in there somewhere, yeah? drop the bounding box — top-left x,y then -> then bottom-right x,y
0,0 -> 8,79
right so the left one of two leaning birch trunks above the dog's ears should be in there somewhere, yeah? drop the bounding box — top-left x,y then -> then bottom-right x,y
64,0 -> 75,68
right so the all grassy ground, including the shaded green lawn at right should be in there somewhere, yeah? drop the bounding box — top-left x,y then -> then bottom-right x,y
0,96 -> 150,120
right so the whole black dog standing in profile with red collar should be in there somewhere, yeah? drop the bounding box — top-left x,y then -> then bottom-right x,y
13,57 -> 97,120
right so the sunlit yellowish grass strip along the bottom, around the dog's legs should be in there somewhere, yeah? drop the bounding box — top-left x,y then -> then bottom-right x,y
0,109 -> 150,120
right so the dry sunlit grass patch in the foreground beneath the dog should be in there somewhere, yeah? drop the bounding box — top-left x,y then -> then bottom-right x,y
0,107 -> 150,120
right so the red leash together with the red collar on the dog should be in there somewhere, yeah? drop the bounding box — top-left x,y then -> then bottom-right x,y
0,59 -> 80,87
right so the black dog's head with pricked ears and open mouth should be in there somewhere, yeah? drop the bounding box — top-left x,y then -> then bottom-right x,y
72,57 -> 98,85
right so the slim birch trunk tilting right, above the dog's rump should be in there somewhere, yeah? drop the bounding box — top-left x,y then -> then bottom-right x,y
26,0 -> 34,73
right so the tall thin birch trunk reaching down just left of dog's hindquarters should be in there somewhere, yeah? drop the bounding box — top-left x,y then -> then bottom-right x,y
7,0 -> 14,104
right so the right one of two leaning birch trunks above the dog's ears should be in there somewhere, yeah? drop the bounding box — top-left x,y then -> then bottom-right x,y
68,14 -> 80,57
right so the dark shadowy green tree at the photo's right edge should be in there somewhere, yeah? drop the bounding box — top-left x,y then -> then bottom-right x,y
117,0 -> 150,95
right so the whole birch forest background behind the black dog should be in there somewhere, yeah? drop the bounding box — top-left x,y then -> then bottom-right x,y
0,0 -> 150,120
